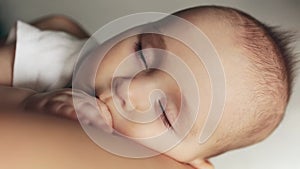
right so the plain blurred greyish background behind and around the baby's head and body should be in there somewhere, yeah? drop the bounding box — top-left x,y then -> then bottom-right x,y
0,0 -> 300,169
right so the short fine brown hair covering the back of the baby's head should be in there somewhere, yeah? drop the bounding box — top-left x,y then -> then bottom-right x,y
204,6 -> 298,154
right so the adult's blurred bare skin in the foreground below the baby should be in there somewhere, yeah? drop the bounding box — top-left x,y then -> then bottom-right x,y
0,110 -> 191,169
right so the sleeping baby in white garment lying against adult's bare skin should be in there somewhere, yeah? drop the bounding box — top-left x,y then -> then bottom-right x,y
0,6 -> 293,169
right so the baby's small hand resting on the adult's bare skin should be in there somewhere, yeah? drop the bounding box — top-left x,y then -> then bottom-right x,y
24,89 -> 112,132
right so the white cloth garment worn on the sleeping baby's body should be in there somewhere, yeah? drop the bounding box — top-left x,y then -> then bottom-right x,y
10,21 -> 85,92
